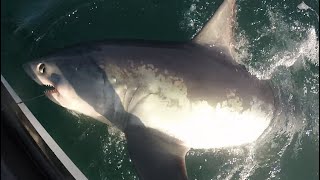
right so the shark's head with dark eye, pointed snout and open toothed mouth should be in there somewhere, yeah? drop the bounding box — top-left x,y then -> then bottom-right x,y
23,56 -> 117,123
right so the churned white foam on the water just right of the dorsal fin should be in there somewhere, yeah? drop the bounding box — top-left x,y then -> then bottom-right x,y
235,11 -> 319,79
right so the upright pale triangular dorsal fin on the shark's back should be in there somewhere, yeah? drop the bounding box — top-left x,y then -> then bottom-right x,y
192,0 -> 235,55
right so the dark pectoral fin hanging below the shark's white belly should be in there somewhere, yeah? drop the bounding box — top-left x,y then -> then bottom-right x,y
125,126 -> 188,180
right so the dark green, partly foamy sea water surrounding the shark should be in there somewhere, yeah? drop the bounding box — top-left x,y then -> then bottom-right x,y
1,0 -> 319,180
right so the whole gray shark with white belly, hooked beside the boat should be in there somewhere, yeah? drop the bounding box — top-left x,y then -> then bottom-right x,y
24,0 -> 275,180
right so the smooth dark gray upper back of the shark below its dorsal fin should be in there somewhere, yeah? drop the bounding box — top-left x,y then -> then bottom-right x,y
50,41 -> 274,110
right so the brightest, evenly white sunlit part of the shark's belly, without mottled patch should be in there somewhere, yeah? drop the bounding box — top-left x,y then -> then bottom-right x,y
127,95 -> 272,149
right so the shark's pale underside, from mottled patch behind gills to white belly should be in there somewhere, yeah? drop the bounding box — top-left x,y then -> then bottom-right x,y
107,62 -> 273,149
